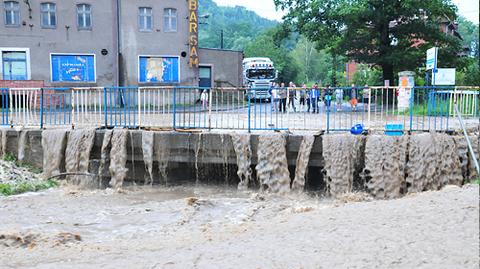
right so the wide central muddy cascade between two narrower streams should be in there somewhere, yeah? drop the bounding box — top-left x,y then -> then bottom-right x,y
256,134 -> 290,193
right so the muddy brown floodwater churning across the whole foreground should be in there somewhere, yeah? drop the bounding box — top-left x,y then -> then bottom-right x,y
0,185 -> 479,269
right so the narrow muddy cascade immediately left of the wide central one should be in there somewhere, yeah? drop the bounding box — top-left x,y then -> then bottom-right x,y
230,133 -> 252,190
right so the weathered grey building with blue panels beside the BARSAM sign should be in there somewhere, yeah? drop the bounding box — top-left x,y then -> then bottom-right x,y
0,0 -> 242,87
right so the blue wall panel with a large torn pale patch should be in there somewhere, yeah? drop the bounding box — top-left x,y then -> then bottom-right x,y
139,56 -> 180,83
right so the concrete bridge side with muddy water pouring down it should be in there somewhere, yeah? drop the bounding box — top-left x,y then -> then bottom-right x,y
1,129 -> 480,199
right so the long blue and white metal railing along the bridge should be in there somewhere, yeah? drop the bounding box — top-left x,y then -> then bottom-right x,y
0,86 -> 480,132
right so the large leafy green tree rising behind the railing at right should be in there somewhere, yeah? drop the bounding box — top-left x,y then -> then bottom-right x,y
274,0 -> 460,82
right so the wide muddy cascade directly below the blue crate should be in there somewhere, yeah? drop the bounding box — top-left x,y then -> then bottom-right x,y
364,135 -> 408,199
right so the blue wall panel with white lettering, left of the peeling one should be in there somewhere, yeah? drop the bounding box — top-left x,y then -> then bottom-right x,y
51,54 -> 95,82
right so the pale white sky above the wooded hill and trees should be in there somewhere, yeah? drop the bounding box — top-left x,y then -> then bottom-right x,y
214,0 -> 479,24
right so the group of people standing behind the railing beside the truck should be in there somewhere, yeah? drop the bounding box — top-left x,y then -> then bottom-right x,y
270,82 -> 370,113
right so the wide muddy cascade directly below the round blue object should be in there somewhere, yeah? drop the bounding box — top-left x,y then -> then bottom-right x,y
322,134 -> 364,197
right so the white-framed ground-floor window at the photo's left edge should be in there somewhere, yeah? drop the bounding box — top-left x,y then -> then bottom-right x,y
2,51 -> 28,80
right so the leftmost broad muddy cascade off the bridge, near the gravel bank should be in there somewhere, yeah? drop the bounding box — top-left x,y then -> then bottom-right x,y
42,130 -> 67,177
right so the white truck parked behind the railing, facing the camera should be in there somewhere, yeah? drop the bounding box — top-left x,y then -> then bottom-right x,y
243,57 -> 278,99
